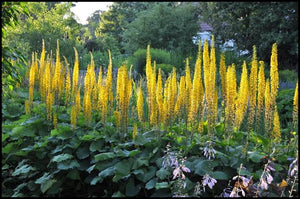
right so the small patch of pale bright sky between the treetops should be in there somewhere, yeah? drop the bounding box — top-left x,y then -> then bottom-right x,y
71,2 -> 113,24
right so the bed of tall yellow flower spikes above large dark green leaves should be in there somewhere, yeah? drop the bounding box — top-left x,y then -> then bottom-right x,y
2,37 -> 298,197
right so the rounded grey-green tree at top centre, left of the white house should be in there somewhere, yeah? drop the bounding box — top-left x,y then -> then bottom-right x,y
123,2 -> 199,53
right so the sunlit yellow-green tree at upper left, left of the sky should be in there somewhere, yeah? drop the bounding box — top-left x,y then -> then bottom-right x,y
3,2 -> 81,60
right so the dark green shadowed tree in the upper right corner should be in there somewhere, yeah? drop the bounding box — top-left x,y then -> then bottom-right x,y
199,1 -> 298,69
